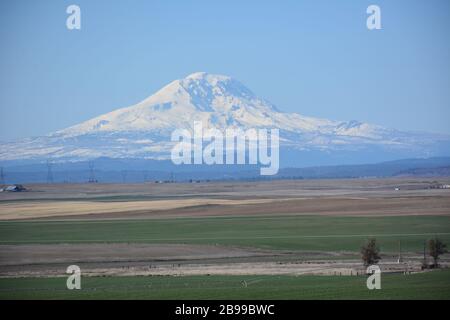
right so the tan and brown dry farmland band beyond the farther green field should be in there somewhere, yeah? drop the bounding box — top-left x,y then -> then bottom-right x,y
0,178 -> 450,220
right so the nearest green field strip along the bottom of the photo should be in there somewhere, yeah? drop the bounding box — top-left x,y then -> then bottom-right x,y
0,270 -> 450,299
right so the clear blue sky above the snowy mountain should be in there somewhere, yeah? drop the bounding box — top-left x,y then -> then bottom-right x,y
0,0 -> 450,140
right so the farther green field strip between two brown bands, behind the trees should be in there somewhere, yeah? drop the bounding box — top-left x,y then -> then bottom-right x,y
0,216 -> 450,252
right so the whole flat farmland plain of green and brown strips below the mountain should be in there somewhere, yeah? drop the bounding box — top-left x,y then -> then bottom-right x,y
0,178 -> 450,299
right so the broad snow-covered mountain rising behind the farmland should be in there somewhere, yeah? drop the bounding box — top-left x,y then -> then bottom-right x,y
0,72 -> 450,166
